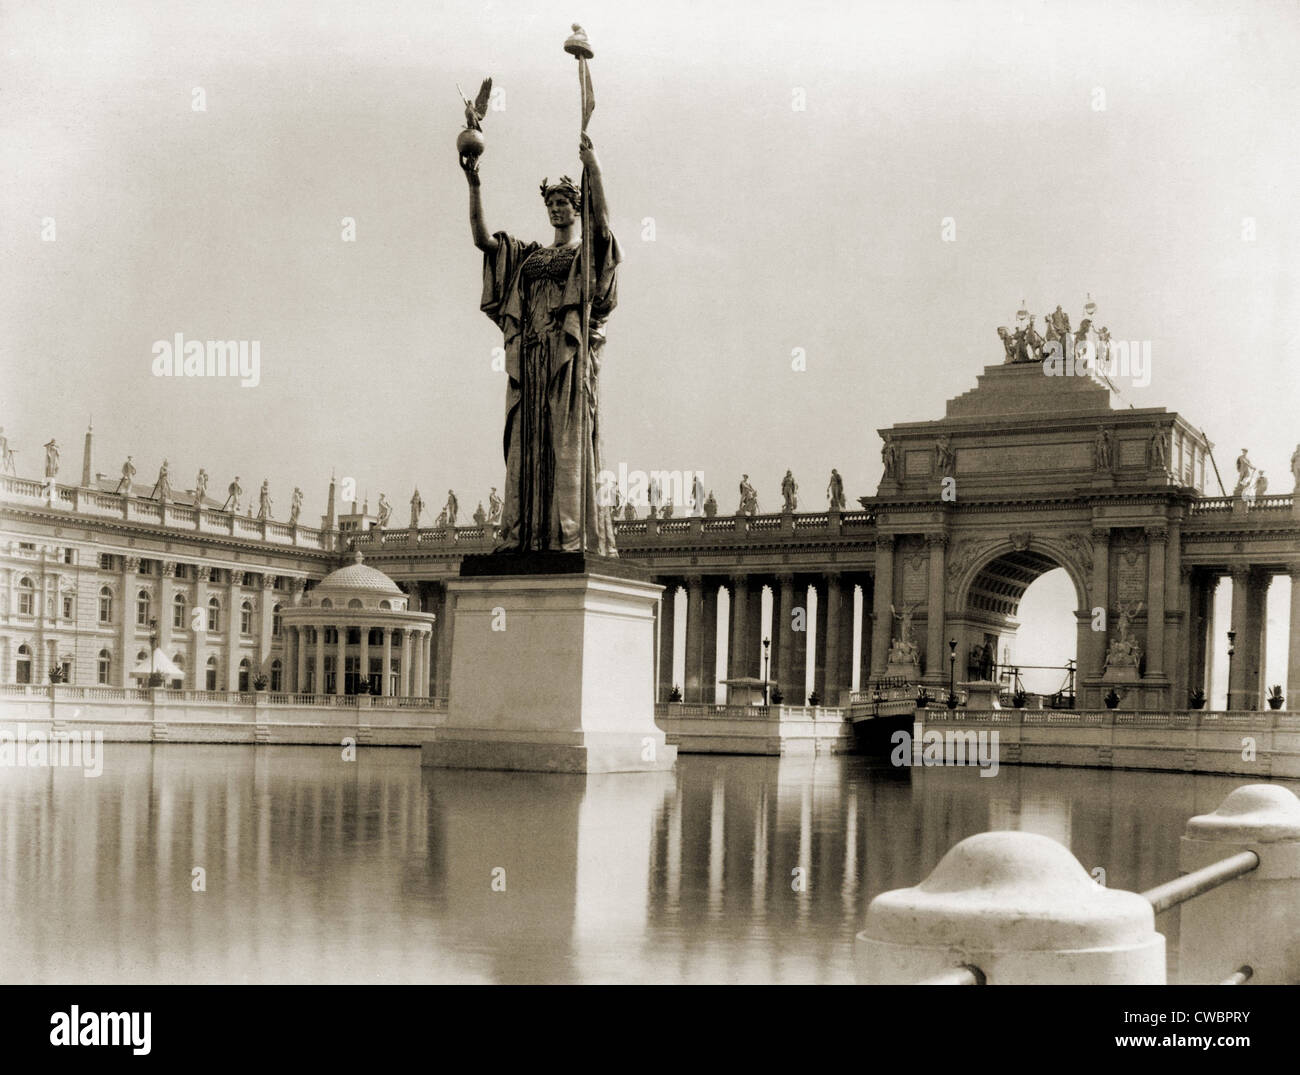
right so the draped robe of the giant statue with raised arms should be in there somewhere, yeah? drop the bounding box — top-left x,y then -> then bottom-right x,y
481,222 -> 623,556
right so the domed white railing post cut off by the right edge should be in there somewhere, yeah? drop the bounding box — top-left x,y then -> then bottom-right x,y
1178,784 -> 1300,985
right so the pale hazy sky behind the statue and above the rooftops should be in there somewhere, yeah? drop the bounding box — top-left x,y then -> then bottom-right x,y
0,0 -> 1300,521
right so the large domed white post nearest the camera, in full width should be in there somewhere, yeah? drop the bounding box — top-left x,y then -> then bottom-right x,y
854,832 -> 1165,985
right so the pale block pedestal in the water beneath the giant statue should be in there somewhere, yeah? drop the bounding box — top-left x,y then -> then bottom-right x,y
421,558 -> 677,772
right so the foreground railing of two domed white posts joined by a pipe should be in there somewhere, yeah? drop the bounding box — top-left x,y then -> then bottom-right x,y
854,784 -> 1300,985
